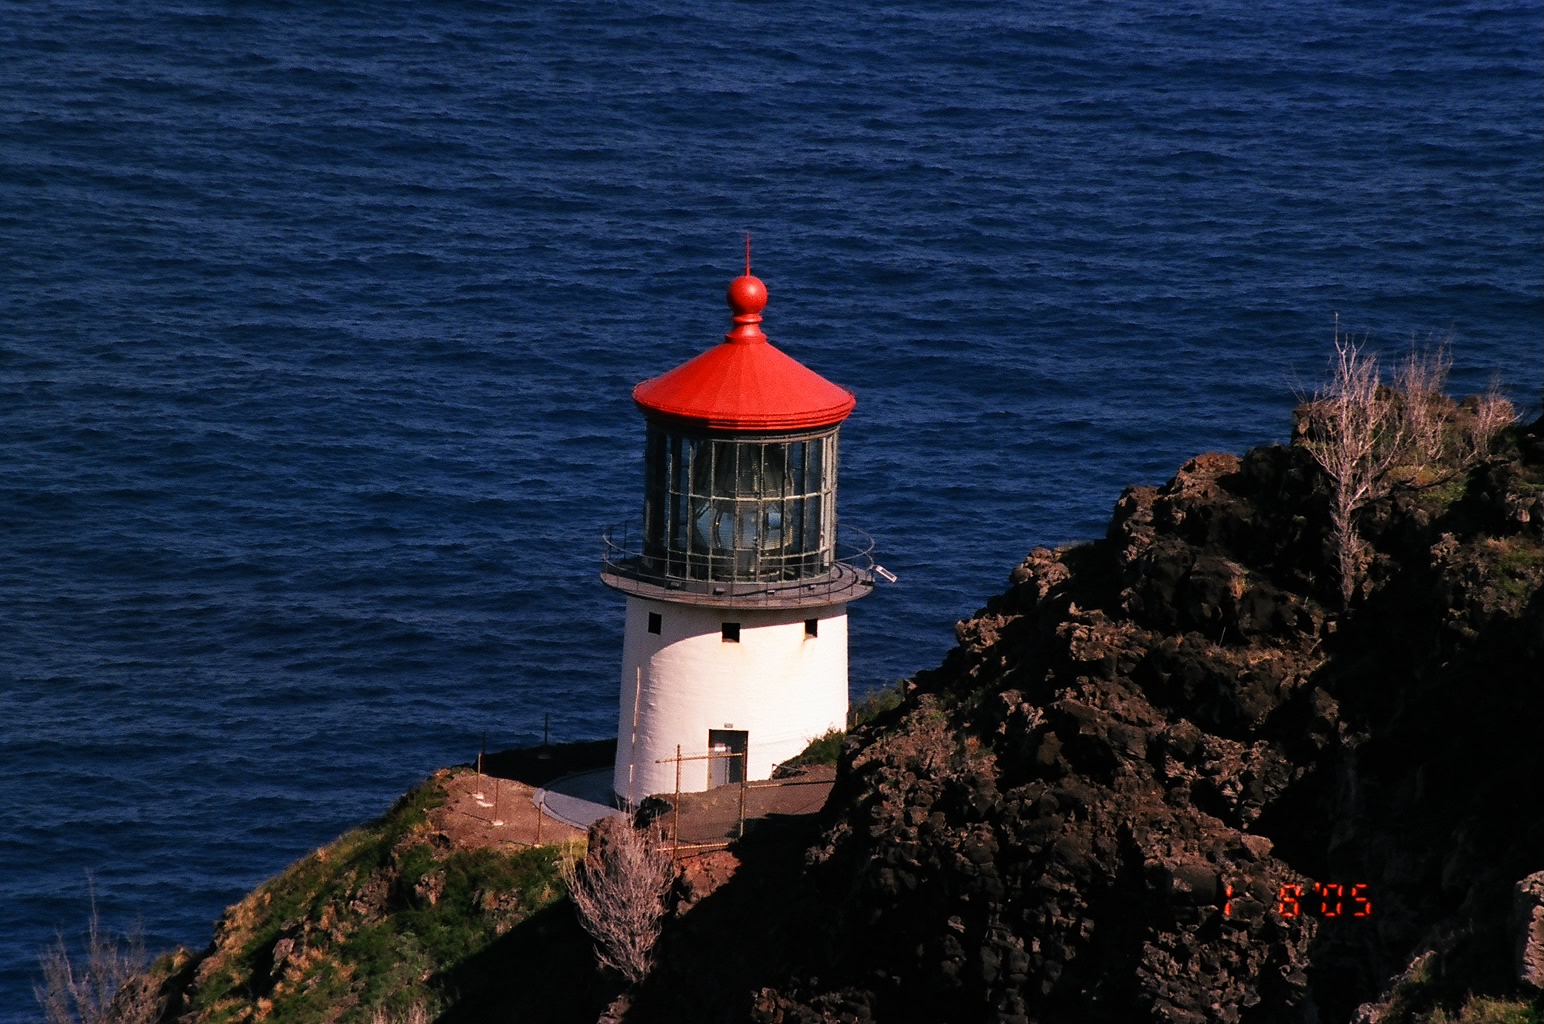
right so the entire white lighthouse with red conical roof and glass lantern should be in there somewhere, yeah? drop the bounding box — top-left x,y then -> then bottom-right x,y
601,261 -> 874,806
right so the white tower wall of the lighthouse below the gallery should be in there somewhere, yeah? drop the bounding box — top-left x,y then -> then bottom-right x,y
613,595 -> 848,805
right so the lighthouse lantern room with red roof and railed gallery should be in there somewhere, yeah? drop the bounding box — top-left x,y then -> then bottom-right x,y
605,267 -> 872,602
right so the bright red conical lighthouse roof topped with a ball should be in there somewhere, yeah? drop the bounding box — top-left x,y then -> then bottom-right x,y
633,269 -> 857,431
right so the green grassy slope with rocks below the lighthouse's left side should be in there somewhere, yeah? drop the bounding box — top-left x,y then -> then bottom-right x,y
157,782 -> 565,1024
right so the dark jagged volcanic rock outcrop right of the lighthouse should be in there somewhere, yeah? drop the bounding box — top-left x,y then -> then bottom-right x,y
628,413 -> 1544,1024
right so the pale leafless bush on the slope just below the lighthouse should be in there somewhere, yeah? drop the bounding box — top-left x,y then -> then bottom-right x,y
562,819 -> 675,984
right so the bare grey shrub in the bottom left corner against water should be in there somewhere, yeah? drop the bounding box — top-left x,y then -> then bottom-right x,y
32,882 -> 159,1024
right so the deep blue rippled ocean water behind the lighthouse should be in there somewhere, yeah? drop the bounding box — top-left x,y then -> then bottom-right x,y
0,0 -> 1544,1024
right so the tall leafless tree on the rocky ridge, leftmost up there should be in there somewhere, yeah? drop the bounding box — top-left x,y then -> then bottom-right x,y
1303,332 -> 1410,604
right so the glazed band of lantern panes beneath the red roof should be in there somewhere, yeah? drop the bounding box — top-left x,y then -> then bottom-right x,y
644,423 -> 837,582
